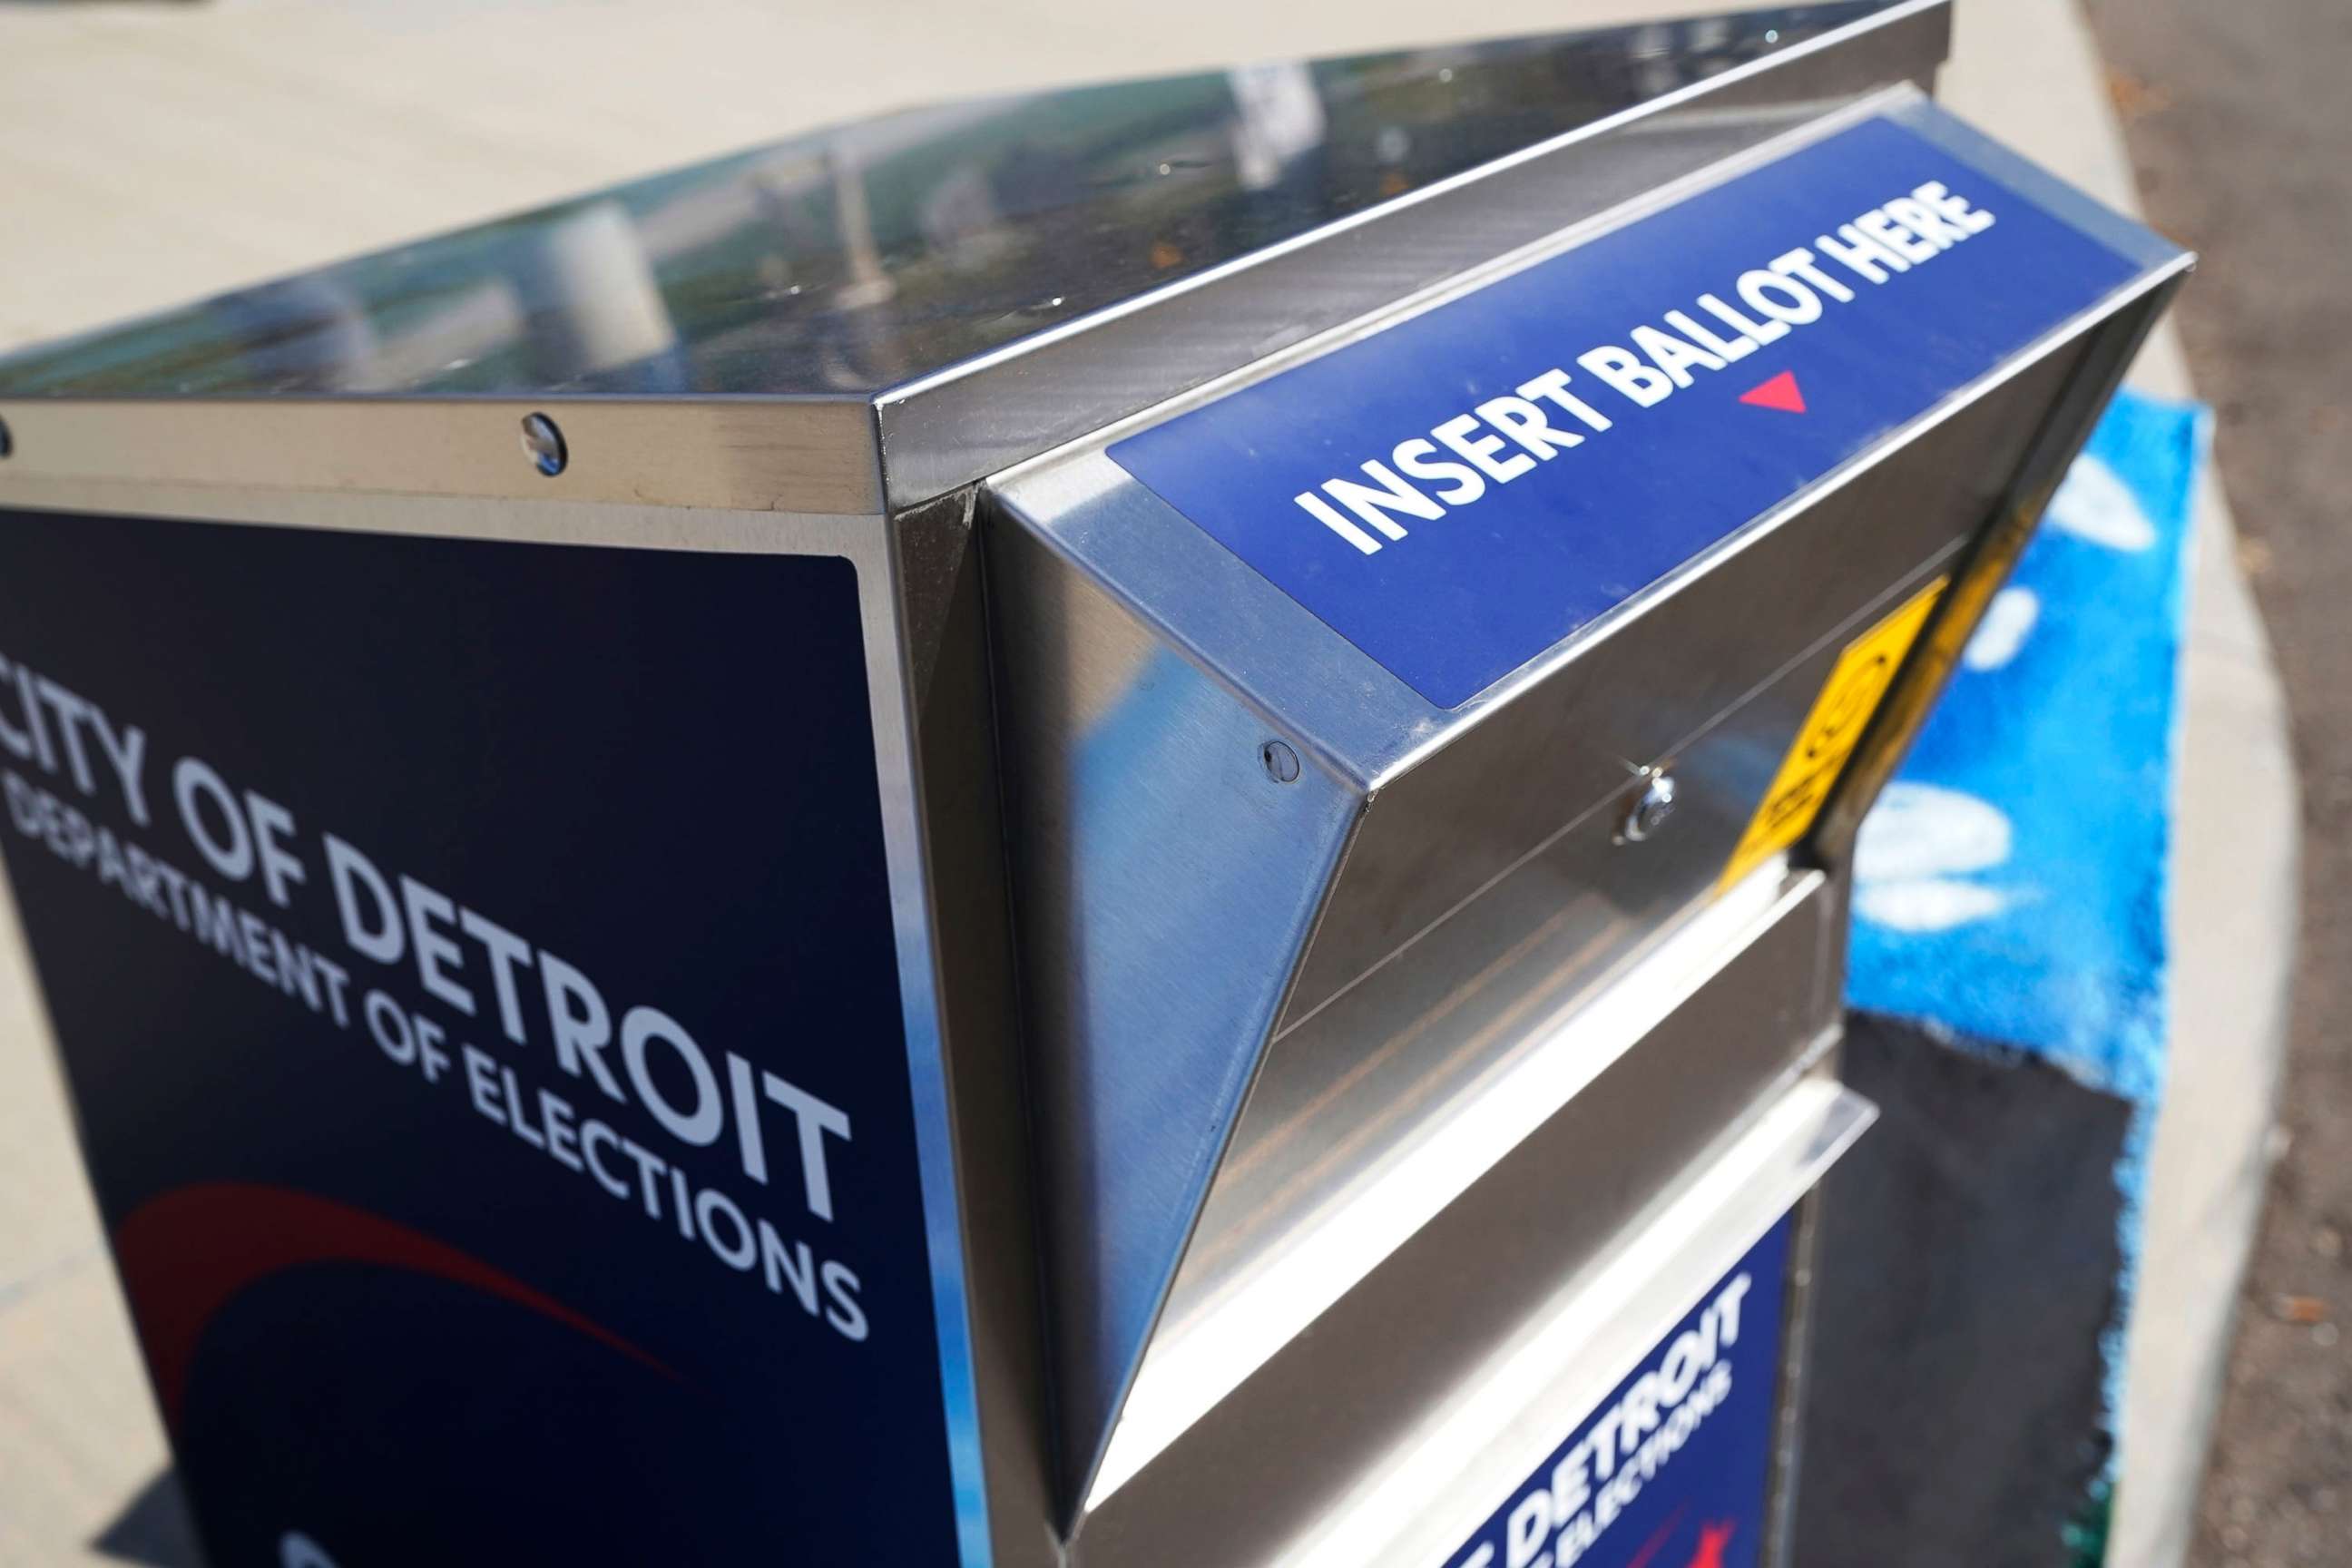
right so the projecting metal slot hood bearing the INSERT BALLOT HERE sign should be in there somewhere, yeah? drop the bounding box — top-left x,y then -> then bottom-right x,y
983,83 -> 2188,1514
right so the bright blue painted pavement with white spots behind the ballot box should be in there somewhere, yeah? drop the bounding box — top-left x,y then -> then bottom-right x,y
1847,393 -> 2209,1102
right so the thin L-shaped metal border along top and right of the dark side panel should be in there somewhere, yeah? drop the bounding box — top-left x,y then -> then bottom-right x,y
0,484 -> 1011,1568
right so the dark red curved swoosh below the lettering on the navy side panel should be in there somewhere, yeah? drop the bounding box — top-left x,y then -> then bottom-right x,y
115,1182 -> 677,1429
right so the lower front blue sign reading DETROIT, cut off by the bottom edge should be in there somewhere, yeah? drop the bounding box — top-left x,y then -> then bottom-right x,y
1446,1220 -> 1790,1568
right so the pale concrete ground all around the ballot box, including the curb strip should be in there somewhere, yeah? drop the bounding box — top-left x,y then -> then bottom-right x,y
0,0 -> 2296,1568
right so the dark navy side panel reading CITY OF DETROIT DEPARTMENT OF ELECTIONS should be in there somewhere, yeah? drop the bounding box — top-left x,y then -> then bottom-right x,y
0,513 -> 955,1568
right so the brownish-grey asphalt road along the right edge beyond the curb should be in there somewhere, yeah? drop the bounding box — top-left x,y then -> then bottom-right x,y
2089,0 -> 2352,1568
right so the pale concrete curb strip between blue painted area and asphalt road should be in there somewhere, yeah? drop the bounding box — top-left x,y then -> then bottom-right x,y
1943,0 -> 2300,1568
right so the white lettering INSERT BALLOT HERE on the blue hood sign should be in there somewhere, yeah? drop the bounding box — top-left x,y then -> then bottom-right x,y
1294,181 -> 1994,554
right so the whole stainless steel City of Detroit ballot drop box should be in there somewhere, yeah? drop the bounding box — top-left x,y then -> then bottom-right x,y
0,0 -> 2188,1568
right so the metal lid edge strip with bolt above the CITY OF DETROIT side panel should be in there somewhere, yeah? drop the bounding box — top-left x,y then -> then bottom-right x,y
0,397 -> 882,513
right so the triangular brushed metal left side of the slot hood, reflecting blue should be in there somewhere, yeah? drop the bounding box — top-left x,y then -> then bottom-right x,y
988,512 -> 1359,1497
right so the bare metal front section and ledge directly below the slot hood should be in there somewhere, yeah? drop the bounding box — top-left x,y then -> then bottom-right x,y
1077,875 -> 1870,1568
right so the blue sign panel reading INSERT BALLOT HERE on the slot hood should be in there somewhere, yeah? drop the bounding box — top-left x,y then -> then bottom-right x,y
1110,120 -> 2138,708
